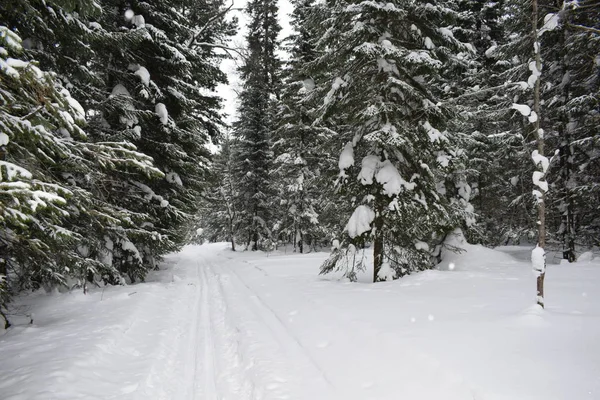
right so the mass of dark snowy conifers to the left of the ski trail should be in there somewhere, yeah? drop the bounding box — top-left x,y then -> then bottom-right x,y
0,0 -> 234,310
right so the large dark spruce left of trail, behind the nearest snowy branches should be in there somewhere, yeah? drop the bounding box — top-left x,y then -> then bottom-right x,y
0,0 -> 233,282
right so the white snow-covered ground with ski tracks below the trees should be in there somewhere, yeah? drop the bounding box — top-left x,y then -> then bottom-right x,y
0,244 -> 600,400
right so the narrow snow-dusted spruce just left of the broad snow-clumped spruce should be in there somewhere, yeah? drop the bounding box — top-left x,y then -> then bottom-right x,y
272,0 -> 326,253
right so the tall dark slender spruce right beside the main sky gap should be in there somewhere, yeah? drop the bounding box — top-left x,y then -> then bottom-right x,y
234,0 -> 281,250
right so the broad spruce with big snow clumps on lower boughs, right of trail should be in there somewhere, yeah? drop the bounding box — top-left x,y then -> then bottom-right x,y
319,1 -> 468,281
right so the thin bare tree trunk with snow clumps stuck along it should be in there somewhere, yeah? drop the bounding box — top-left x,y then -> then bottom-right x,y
531,0 -> 547,307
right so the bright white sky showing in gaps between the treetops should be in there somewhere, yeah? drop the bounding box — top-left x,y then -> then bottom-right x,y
217,0 -> 293,123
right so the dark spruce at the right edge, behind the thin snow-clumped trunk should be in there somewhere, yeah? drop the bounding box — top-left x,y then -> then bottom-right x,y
541,1 -> 600,262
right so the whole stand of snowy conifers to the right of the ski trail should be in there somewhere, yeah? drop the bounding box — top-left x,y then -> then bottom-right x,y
199,0 -> 599,294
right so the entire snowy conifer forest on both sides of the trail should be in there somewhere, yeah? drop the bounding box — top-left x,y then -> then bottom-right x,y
0,0 -> 600,324
